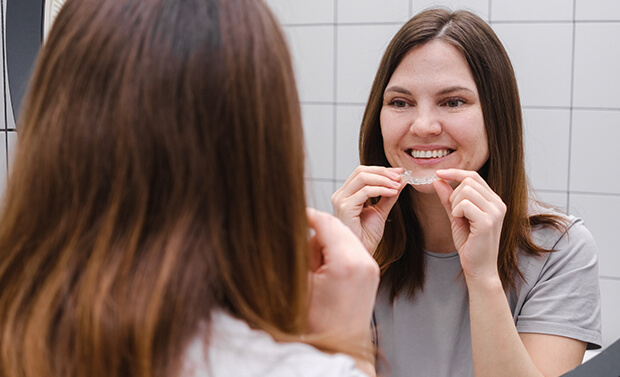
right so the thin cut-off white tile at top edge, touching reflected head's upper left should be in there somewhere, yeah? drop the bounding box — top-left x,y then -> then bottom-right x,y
337,0 -> 409,23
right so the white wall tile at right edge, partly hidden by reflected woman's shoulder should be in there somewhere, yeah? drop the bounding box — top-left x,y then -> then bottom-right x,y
570,194 -> 620,280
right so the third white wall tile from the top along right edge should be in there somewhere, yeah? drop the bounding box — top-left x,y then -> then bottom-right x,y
569,110 -> 620,194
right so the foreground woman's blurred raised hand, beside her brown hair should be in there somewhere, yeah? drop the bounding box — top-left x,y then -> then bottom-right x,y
308,209 -> 379,338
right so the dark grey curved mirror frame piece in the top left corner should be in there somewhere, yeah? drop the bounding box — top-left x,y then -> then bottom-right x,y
6,0 -> 45,117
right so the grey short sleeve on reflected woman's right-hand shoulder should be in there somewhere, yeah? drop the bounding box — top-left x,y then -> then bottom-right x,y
516,217 -> 601,349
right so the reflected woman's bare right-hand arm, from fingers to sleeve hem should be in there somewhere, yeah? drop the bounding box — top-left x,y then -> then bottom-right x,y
433,169 -> 585,377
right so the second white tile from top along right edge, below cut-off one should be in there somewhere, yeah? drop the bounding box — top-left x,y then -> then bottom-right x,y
573,23 -> 620,109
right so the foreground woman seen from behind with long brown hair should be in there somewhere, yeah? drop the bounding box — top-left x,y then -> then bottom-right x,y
0,0 -> 379,377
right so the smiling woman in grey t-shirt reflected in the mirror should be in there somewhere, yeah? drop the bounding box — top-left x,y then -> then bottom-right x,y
332,9 -> 601,377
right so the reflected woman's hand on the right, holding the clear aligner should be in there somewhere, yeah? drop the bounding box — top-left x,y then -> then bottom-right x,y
433,169 -> 506,281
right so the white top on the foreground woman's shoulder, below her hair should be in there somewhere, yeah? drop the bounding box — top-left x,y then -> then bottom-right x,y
182,310 -> 368,377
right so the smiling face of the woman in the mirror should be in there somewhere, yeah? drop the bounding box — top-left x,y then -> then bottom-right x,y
380,40 -> 489,191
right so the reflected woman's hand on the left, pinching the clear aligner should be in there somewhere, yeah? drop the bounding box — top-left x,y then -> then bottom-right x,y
331,165 -> 406,254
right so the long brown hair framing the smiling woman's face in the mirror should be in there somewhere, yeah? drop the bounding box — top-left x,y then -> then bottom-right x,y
359,9 -> 561,299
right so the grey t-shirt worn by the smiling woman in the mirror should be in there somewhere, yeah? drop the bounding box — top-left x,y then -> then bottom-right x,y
375,212 -> 601,377
